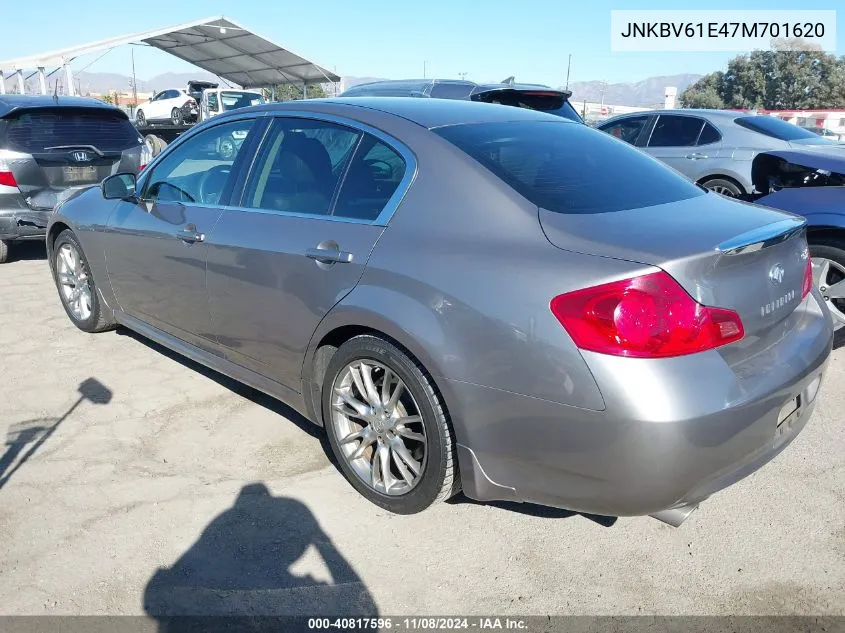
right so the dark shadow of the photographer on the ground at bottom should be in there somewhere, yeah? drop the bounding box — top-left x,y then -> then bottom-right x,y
143,483 -> 378,632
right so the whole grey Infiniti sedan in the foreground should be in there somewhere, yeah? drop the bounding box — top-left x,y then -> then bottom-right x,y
47,97 -> 833,525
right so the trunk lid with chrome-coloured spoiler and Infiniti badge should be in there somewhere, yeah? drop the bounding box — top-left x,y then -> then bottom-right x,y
540,194 -> 808,335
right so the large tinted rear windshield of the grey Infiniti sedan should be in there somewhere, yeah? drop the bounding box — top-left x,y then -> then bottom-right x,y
434,121 -> 705,213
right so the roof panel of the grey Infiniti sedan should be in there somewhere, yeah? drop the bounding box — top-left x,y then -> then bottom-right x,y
232,97 -> 571,129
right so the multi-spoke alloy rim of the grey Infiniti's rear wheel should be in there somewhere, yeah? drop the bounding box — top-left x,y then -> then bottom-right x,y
331,359 -> 428,496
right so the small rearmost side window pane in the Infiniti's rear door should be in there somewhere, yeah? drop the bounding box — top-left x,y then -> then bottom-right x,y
333,134 -> 407,222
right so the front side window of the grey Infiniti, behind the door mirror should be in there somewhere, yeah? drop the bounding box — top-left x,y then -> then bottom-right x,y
143,119 -> 255,204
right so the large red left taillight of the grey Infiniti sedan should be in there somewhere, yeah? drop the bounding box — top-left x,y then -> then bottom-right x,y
550,271 -> 745,358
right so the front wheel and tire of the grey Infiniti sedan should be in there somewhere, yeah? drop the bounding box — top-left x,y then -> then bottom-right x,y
50,229 -> 116,333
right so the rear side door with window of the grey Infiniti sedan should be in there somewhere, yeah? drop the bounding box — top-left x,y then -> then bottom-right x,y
208,117 -> 413,391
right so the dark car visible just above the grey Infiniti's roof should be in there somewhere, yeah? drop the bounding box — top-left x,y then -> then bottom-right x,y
340,78 -> 583,123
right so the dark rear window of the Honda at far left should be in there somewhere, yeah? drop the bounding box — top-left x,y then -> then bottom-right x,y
2,108 -> 141,154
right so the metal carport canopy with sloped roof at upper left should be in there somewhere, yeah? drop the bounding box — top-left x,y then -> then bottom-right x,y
0,16 -> 340,88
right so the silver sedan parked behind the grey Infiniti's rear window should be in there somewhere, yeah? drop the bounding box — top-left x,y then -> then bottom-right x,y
596,109 -> 835,197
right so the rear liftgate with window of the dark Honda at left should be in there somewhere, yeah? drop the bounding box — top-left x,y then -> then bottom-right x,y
0,107 -> 143,212
